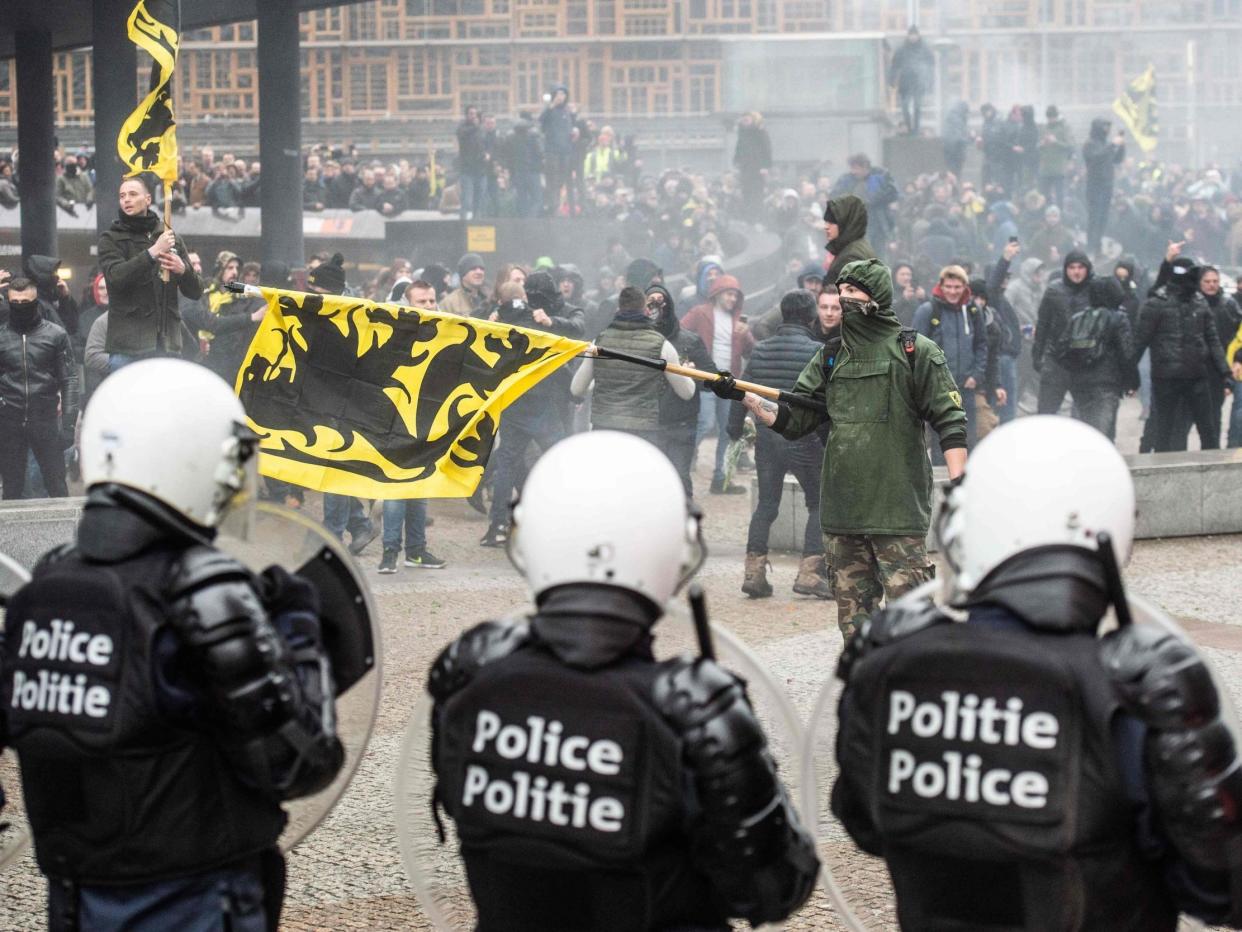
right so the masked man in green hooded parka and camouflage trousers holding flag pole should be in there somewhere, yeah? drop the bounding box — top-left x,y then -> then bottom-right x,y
730,258 -> 966,640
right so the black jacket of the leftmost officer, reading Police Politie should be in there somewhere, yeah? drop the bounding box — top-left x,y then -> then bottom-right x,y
0,493 -> 325,885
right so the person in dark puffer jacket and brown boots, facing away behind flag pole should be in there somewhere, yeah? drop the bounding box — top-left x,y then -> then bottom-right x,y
728,288 -> 832,599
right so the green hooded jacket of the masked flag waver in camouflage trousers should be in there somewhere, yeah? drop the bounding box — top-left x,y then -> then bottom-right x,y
773,258 -> 966,537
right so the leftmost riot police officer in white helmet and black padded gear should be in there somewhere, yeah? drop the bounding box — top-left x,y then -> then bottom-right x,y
0,359 -> 343,932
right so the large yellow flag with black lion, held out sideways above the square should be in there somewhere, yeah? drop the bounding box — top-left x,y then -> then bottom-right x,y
236,288 -> 589,500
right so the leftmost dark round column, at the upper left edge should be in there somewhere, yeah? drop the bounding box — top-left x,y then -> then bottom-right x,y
14,31 -> 56,263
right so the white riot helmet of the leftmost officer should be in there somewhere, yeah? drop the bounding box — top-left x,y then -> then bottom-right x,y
82,359 -> 256,527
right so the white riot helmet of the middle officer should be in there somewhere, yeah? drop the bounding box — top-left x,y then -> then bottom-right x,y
509,430 -> 703,609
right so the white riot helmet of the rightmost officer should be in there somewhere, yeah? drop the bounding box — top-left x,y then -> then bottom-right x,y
936,415 -> 1135,603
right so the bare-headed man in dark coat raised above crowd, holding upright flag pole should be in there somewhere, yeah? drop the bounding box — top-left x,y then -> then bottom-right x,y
99,178 -> 202,372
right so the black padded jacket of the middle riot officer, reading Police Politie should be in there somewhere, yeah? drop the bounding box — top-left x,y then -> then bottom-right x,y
428,587 -> 817,932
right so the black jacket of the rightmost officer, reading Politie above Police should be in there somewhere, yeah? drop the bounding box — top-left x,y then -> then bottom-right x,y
832,605 -> 1192,932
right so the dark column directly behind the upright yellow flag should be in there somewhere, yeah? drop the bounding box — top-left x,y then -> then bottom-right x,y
91,0 -> 138,241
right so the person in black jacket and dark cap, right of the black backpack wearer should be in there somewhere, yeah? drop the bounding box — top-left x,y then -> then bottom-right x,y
1134,256 -> 1230,454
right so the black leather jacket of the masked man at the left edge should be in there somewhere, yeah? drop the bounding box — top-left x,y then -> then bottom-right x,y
0,318 -> 78,424
